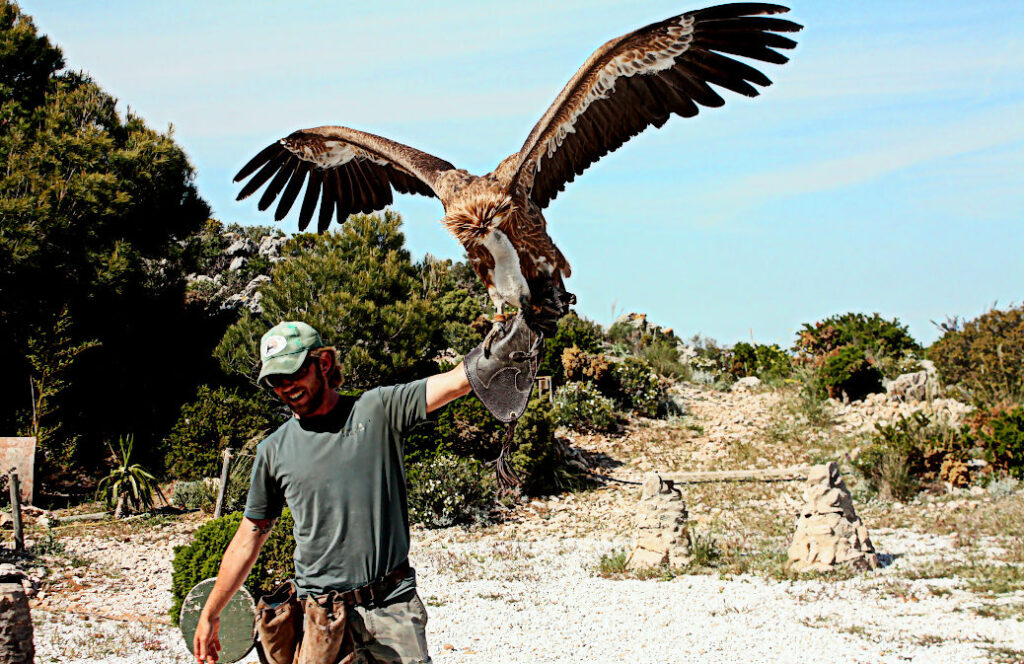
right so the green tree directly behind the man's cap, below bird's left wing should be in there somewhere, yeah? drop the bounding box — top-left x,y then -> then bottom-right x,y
215,211 -> 440,389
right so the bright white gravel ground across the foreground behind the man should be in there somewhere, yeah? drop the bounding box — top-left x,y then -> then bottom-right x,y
28,532 -> 1024,664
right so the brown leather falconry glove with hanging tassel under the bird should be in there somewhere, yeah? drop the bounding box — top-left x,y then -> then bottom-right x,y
463,315 -> 544,488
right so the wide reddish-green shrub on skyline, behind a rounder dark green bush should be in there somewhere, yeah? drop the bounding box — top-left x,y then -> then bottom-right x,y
794,313 -> 921,357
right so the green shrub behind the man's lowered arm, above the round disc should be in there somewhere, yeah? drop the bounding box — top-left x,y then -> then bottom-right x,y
171,508 -> 295,625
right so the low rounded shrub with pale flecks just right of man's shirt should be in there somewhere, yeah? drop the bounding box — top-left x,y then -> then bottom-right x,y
406,452 -> 495,528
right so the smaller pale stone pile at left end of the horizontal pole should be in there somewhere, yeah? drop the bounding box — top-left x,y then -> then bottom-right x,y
626,472 -> 693,570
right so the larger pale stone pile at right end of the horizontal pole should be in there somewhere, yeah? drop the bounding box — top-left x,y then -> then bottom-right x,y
788,461 -> 879,572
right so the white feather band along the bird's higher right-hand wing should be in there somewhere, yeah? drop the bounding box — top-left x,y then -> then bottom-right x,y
537,16 -> 693,172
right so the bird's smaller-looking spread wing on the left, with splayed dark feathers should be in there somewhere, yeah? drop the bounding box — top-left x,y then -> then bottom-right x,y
234,127 -> 455,232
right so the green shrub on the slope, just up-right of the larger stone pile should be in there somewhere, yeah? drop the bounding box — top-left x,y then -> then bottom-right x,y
854,412 -> 970,500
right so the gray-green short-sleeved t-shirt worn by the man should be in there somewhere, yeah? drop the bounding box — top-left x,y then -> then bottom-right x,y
245,379 -> 427,596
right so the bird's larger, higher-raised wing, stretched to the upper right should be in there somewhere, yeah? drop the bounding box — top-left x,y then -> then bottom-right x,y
512,3 -> 801,208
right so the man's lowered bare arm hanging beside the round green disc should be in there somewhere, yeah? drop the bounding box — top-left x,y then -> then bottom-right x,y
193,516 -> 274,664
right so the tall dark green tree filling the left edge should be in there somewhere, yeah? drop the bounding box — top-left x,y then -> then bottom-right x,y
0,0 -> 214,478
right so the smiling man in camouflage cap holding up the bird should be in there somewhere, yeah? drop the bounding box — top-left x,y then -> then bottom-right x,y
194,322 -> 479,664
